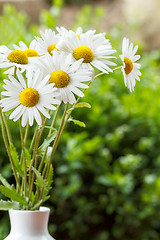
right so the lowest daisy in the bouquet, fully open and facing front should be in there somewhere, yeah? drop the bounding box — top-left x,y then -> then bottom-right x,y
0,70 -> 59,127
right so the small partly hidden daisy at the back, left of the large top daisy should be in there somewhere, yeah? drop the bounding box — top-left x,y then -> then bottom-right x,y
35,29 -> 59,55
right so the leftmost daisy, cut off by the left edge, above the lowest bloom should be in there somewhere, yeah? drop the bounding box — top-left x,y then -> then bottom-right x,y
0,46 -> 34,73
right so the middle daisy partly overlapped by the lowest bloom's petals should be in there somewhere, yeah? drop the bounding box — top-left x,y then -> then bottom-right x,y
30,50 -> 92,104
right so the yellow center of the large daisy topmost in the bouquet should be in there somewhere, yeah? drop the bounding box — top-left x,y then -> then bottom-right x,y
73,46 -> 94,63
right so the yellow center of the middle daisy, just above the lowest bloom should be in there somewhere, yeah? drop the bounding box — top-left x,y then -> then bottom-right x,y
49,70 -> 69,88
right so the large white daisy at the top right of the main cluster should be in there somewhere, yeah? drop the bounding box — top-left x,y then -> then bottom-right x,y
57,31 -> 116,73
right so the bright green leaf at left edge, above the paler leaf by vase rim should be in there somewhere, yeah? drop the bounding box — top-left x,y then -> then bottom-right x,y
0,185 -> 27,205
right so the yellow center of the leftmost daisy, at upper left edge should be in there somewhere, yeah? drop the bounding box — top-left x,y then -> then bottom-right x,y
7,50 -> 28,64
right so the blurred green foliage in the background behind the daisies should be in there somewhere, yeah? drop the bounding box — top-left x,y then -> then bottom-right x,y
0,2 -> 160,240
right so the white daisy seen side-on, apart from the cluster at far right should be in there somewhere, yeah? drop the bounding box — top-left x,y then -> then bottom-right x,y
120,37 -> 141,92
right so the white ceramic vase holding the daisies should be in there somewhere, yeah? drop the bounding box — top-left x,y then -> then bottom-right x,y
4,207 -> 55,240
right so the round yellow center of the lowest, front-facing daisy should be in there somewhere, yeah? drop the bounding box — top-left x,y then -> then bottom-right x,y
19,88 -> 39,107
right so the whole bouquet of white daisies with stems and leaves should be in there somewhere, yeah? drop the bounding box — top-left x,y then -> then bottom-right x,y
0,27 -> 141,210
